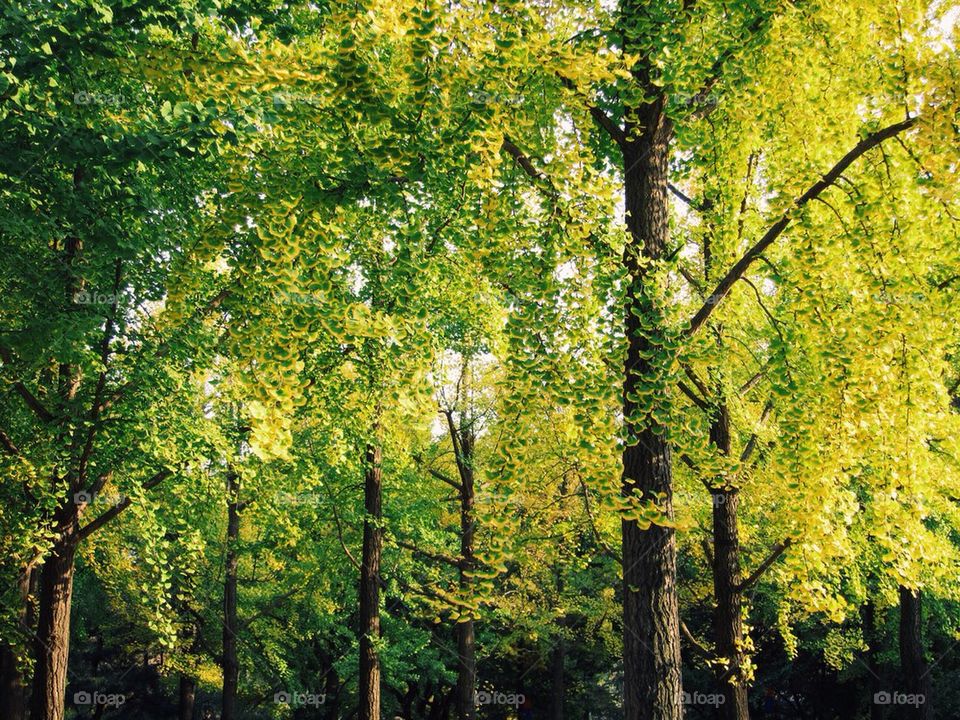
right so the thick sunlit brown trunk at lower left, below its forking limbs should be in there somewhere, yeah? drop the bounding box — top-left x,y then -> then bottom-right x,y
30,536 -> 77,720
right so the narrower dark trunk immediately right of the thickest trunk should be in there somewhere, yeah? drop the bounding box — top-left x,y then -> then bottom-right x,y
710,402 -> 750,720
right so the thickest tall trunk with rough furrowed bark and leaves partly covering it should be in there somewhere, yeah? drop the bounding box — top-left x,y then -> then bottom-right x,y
621,98 -> 683,720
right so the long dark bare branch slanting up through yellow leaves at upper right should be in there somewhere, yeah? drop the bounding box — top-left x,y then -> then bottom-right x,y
686,117 -> 917,336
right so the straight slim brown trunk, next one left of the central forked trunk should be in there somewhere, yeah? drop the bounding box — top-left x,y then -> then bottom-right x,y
359,444 -> 383,720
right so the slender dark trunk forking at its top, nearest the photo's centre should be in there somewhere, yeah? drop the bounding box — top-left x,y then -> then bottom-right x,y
451,422 -> 477,720
